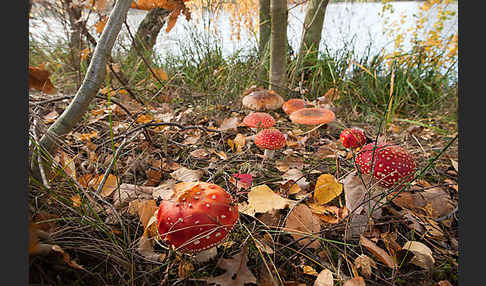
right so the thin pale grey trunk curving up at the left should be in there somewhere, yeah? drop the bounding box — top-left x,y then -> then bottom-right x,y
33,0 -> 132,168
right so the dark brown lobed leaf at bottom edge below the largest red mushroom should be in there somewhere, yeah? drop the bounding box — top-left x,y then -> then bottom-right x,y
206,246 -> 257,286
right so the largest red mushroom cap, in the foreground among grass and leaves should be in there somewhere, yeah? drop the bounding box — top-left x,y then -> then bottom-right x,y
157,182 -> 238,252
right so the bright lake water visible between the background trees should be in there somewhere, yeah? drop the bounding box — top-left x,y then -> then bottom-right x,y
30,1 -> 458,71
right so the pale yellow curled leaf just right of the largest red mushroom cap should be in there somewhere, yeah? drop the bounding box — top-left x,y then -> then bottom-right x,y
238,185 -> 293,216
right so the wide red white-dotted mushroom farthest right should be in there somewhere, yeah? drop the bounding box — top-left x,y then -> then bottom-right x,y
355,143 -> 415,188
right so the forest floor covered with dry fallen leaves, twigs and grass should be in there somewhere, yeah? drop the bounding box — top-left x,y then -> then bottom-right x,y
29,77 -> 459,285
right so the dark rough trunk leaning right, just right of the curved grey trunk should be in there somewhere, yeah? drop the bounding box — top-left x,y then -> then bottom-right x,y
130,8 -> 170,54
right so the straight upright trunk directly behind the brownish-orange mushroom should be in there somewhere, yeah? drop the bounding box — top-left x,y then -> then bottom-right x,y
270,0 -> 287,96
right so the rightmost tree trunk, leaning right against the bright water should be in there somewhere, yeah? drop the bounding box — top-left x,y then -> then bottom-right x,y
291,0 -> 329,86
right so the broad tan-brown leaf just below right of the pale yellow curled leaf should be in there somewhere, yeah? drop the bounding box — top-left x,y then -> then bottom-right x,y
284,204 -> 321,248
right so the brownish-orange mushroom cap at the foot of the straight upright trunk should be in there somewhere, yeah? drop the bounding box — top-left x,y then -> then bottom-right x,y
242,88 -> 284,111
